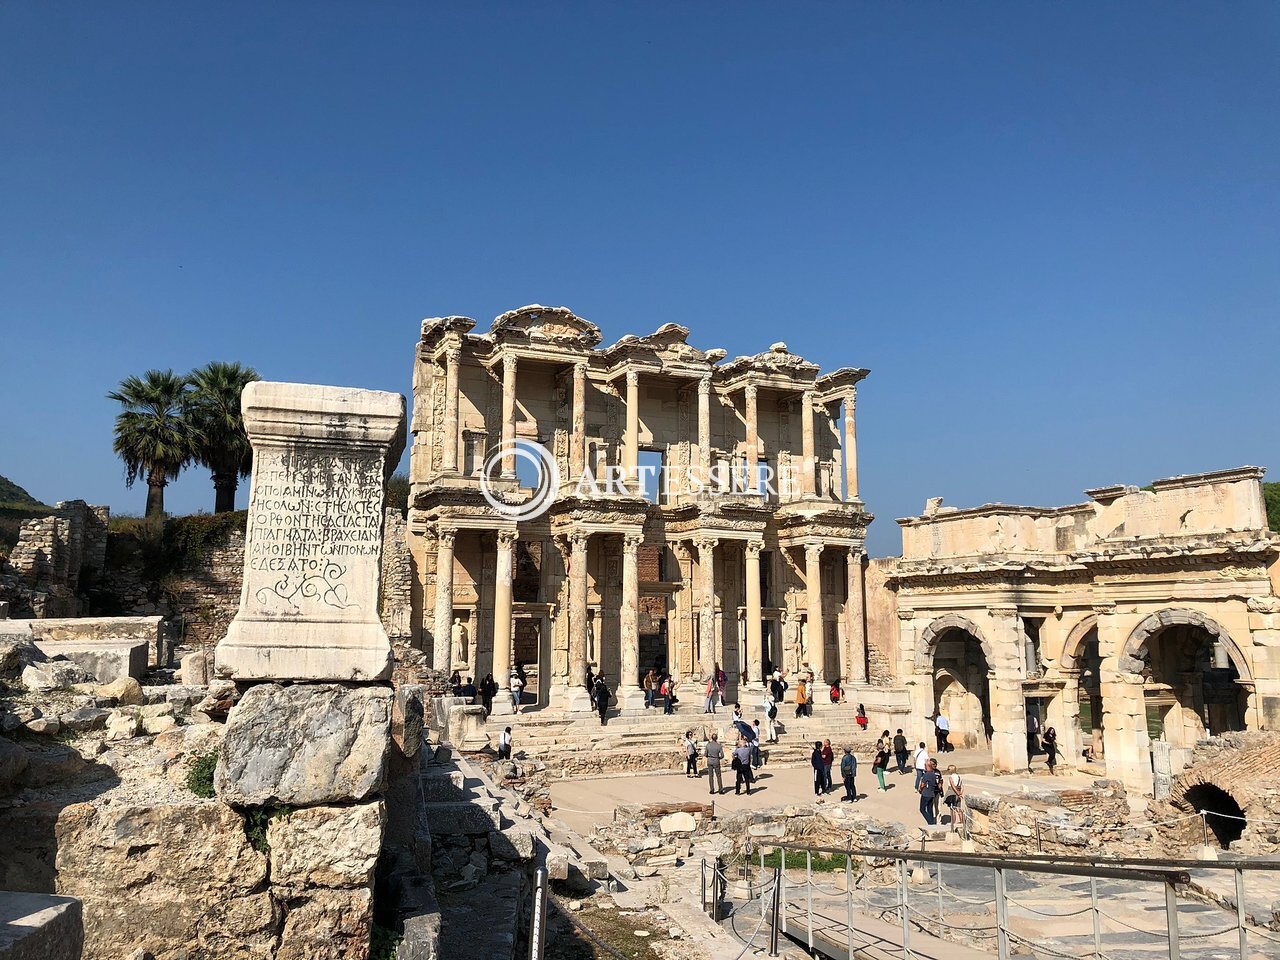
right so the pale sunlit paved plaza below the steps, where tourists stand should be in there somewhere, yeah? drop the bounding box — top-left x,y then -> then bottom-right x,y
552,750 -> 1093,833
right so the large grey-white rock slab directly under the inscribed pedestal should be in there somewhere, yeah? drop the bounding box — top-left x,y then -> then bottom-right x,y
215,684 -> 390,806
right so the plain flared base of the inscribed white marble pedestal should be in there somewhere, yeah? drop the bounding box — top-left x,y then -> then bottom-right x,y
214,618 -> 392,681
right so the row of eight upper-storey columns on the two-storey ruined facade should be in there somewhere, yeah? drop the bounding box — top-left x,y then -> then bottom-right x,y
442,347 -> 858,499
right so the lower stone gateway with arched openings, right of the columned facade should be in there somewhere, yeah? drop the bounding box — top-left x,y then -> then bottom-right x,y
873,467 -> 1280,792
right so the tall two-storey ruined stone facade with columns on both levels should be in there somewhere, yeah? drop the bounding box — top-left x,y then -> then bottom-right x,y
410,305 -> 872,708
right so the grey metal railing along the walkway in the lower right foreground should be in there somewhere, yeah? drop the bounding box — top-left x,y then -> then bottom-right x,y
703,844 -> 1280,960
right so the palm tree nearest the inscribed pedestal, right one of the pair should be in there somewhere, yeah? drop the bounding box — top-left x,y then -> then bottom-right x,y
187,360 -> 262,513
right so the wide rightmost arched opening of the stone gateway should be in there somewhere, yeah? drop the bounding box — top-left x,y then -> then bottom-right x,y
1125,611 -> 1251,748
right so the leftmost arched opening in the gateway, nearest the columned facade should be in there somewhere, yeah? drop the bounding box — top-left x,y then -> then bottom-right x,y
924,617 -> 992,748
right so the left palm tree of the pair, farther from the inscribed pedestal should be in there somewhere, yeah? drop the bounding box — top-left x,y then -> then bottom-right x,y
106,370 -> 196,517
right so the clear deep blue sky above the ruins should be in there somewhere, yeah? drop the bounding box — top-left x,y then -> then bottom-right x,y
0,0 -> 1280,554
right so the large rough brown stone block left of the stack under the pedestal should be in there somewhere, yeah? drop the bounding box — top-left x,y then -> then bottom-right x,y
56,800 -> 273,960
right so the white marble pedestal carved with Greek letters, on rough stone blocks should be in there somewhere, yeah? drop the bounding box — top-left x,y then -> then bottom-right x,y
215,381 -> 404,680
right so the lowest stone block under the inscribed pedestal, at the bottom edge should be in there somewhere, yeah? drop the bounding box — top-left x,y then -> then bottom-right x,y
273,887 -> 374,960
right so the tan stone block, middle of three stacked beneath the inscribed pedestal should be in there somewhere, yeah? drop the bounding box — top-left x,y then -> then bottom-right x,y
266,800 -> 387,888
